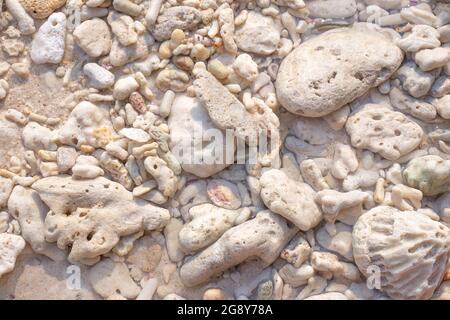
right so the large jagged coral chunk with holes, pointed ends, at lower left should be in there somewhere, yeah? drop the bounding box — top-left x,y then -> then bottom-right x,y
32,176 -> 170,264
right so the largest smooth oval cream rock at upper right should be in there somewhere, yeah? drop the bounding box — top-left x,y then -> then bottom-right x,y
276,27 -> 403,117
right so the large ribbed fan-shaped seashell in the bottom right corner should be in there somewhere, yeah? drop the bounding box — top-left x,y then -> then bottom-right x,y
352,206 -> 450,300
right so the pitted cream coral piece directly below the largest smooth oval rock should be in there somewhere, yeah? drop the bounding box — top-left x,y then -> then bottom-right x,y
345,104 -> 423,160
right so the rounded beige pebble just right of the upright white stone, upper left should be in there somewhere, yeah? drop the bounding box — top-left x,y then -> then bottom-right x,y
73,18 -> 112,58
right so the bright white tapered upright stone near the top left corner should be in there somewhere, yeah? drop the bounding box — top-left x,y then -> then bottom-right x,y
30,12 -> 66,64
